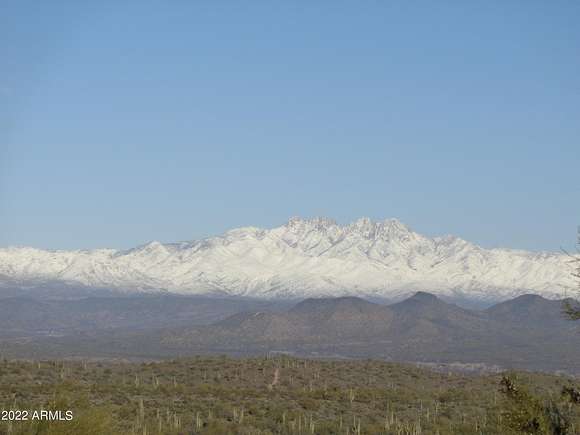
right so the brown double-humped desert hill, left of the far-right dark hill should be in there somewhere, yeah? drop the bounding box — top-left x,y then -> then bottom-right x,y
161,292 -> 486,346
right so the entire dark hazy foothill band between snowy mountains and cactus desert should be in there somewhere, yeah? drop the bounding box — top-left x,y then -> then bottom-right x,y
0,292 -> 580,374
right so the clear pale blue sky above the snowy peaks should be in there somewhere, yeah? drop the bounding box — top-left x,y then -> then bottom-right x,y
0,0 -> 580,251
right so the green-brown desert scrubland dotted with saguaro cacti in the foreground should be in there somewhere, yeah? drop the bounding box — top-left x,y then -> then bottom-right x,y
0,355 -> 580,435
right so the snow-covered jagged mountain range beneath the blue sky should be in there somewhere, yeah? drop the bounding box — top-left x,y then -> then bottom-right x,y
0,218 -> 576,301
